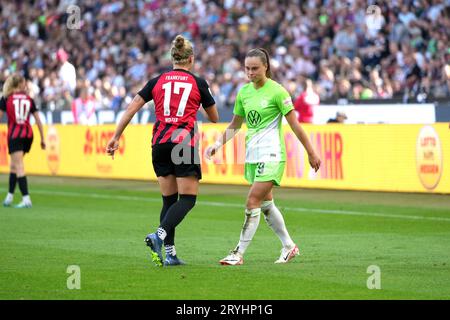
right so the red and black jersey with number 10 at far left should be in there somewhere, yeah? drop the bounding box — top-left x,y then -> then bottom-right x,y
0,93 -> 37,139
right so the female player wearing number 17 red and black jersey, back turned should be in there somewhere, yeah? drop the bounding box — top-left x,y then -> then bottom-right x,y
106,35 -> 219,266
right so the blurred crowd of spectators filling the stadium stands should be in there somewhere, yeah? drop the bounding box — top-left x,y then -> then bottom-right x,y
0,0 -> 450,110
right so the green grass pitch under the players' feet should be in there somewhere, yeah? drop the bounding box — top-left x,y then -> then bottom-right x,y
0,175 -> 450,300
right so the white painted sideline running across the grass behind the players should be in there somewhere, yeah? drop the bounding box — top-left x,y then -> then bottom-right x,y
33,190 -> 450,222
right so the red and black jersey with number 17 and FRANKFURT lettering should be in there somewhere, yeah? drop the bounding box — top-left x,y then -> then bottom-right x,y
138,69 -> 215,146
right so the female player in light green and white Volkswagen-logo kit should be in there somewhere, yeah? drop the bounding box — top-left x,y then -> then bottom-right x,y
205,48 -> 320,265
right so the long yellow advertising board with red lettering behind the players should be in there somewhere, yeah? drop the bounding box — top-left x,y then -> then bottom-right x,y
0,124 -> 450,193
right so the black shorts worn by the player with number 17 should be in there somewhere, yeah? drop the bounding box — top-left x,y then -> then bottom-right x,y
152,143 -> 202,180
